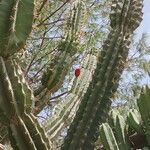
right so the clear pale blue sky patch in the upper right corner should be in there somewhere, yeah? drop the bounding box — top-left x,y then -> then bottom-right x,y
136,0 -> 150,44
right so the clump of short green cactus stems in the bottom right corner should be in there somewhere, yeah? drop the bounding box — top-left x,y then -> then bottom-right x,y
100,86 -> 150,149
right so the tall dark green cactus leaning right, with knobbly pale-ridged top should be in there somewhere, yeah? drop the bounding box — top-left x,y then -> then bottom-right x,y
62,0 -> 143,150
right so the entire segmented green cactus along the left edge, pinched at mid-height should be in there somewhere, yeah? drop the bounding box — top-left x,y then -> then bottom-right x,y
0,0 -> 51,150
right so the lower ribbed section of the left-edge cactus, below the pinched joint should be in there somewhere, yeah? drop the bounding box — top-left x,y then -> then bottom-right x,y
0,57 -> 50,150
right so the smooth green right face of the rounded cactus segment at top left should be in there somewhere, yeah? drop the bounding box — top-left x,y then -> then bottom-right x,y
8,0 -> 34,51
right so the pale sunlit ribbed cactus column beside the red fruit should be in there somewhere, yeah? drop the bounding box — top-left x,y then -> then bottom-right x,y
43,54 -> 96,148
